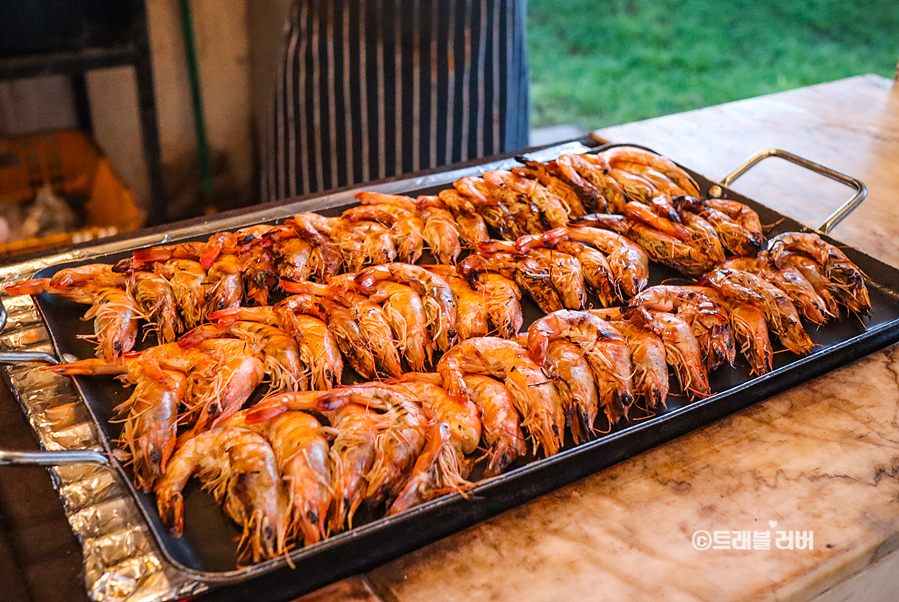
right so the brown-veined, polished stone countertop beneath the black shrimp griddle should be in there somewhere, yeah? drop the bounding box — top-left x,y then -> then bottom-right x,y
0,76 -> 899,602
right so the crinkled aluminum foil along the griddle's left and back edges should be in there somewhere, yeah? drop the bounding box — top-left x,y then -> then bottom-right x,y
0,142 -> 589,602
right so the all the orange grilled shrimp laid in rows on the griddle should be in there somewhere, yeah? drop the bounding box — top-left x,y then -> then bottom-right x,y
6,147 -> 871,563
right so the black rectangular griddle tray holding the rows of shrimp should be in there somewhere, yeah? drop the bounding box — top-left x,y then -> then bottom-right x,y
7,138 -> 899,600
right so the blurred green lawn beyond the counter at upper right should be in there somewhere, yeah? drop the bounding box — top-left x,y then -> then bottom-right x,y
527,0 -> 899,128
